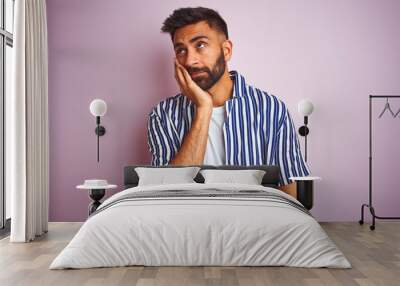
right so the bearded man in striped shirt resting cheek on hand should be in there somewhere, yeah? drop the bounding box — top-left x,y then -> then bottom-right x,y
148,7 -> 310,196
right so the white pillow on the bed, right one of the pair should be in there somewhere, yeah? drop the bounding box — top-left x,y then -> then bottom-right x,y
200,169 -> 265,185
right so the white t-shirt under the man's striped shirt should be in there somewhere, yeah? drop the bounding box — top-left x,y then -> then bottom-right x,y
203,106 -> 225,165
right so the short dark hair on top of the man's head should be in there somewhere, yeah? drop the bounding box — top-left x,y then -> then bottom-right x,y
161,7 -> 228,39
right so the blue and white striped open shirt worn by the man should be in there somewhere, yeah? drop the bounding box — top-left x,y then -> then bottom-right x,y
147,71 -> 310,185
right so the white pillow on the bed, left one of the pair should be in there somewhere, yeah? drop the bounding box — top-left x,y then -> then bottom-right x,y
135,167 -> 200,186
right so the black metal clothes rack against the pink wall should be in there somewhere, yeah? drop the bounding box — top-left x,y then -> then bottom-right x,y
359,95 -> 400,230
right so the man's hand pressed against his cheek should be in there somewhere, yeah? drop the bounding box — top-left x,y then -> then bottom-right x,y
175,59 -> 213,108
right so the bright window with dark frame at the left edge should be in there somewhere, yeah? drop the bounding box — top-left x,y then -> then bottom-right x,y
0,0 -> 14,233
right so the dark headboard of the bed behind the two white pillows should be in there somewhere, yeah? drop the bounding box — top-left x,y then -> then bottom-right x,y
124,165 -> 279,189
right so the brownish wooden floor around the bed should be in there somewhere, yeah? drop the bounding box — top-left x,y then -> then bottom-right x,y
0,222 -> 400,286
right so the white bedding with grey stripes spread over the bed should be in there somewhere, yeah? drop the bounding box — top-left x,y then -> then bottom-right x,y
50,183 -> 351,269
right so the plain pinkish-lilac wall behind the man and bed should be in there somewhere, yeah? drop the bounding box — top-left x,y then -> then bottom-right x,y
47,0 -> 400,221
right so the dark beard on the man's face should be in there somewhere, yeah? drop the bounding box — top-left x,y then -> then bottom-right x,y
187,49 -> 226,90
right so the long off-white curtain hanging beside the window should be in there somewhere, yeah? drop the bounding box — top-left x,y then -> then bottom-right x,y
6,0 -> 49,242
